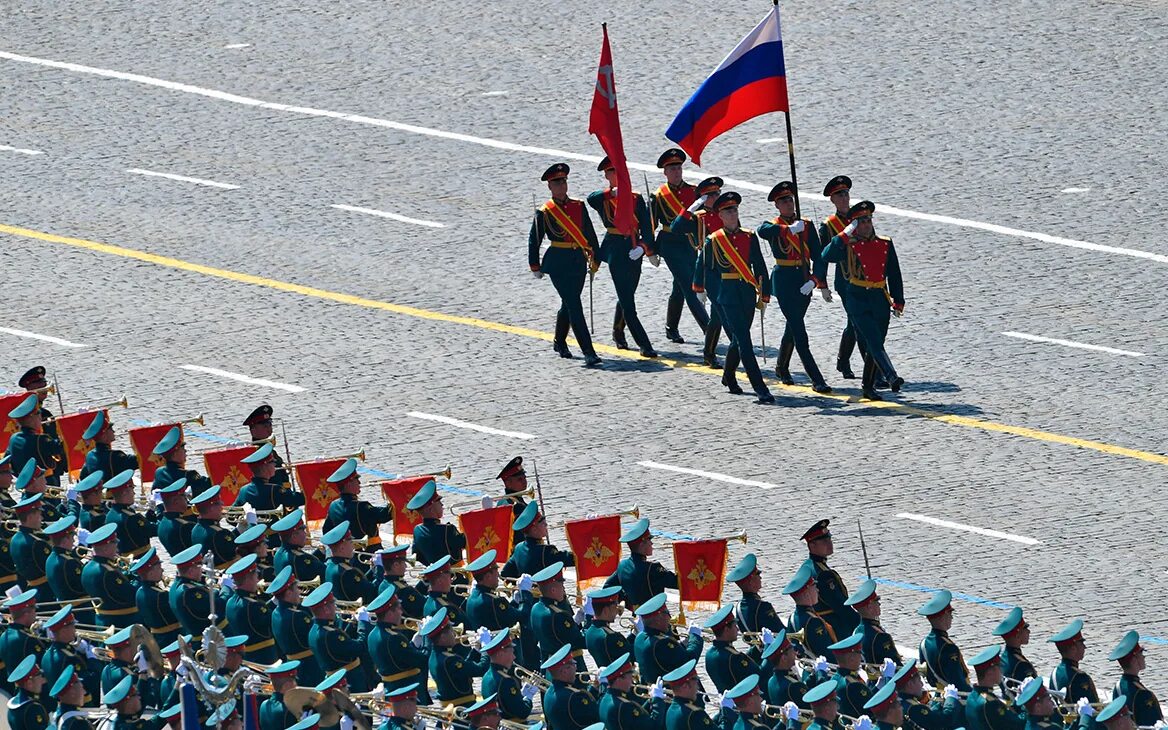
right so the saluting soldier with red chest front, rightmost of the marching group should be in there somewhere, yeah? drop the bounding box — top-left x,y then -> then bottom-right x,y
823,200 -> 904,401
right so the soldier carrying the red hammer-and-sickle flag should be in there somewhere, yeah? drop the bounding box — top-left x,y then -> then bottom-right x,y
588,155 -> 660,357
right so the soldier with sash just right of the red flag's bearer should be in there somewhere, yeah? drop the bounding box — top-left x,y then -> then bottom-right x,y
649,147 -> 710,345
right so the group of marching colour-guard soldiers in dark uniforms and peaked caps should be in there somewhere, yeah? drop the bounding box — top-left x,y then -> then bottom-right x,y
528,148 -> 904,403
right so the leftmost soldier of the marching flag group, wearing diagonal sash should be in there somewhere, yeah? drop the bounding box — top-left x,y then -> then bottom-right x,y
527,162 -> 602,368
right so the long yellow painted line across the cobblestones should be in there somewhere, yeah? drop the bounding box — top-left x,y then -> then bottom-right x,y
9,223 -> 1168,466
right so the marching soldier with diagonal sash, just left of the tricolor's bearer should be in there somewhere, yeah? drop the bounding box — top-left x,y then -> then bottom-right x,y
694,193 -> 774,403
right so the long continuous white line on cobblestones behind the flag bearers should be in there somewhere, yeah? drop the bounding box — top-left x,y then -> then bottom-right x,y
0,51 -> 1168,264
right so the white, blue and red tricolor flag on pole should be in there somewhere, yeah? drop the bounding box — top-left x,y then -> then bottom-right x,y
665,5 -> 790,165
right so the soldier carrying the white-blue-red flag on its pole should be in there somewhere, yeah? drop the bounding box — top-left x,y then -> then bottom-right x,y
758,181 -> 832,392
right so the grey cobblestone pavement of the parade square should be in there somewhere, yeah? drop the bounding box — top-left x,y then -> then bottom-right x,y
0,0 -> 1168,695
